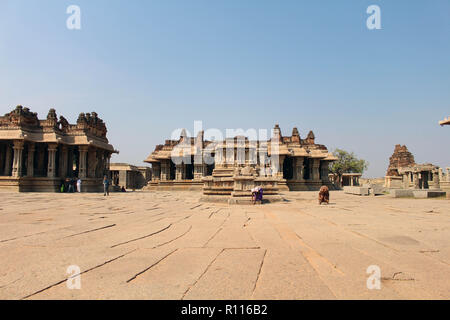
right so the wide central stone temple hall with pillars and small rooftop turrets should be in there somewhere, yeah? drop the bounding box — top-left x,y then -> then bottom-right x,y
145,125 -> 337,196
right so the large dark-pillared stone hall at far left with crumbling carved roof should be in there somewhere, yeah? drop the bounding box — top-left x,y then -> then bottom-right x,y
0,106 -> 117,192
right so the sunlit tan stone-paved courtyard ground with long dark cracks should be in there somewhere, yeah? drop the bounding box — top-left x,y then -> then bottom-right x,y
0,192 -> 450,299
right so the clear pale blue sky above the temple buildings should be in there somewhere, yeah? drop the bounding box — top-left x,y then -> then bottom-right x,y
0,0 -> 450,177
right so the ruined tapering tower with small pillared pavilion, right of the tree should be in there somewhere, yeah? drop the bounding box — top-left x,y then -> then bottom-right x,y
385,145 -> 440,189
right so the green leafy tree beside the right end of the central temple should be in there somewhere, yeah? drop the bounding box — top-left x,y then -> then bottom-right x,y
330,149 -> 369,186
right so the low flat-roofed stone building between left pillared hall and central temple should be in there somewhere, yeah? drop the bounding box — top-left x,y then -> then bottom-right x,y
109,163 -> 151,191
